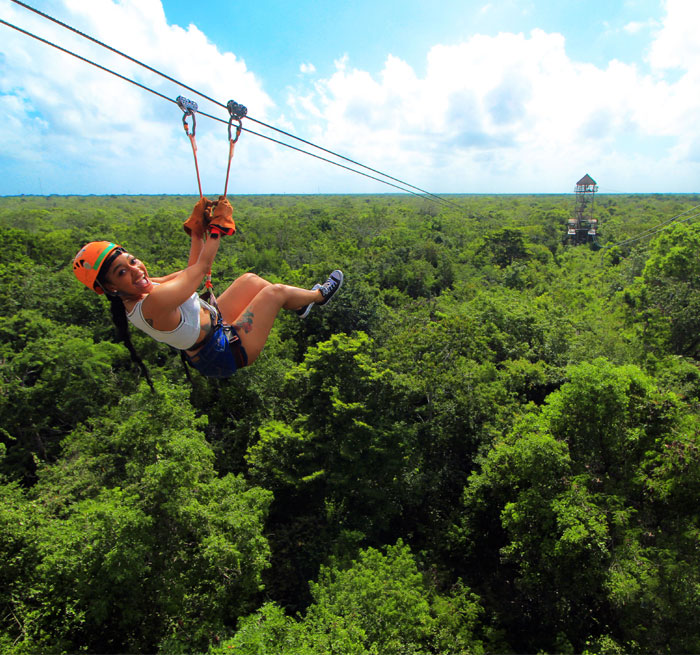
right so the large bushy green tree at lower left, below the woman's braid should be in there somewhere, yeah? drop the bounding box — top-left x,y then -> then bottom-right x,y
6,385 -> 271,653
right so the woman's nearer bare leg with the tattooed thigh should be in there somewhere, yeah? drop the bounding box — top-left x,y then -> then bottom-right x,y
234,280 -> 323,364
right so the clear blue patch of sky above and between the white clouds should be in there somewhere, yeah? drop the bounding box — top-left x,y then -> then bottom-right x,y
163,0 -> 663,94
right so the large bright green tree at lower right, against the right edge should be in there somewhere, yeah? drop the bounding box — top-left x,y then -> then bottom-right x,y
459,360 -> 700,652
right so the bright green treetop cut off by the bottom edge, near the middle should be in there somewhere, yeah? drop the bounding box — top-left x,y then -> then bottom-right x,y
215,541 -> 484,655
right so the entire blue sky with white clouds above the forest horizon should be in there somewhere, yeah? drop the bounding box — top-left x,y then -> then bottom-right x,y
0,0 -> 700,195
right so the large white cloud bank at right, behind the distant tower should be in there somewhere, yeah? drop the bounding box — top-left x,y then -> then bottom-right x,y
284,16 -> 700,192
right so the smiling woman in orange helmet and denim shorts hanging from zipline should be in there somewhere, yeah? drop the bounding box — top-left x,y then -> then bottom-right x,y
73,196 -> 343,378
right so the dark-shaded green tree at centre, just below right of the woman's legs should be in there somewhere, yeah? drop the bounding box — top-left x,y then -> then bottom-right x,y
247,333 -> 414,532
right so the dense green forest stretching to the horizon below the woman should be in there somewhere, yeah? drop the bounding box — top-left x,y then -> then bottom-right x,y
0,195 -> 700,655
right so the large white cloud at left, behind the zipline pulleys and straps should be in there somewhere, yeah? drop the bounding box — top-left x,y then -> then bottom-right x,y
0,0 -> 274,193
